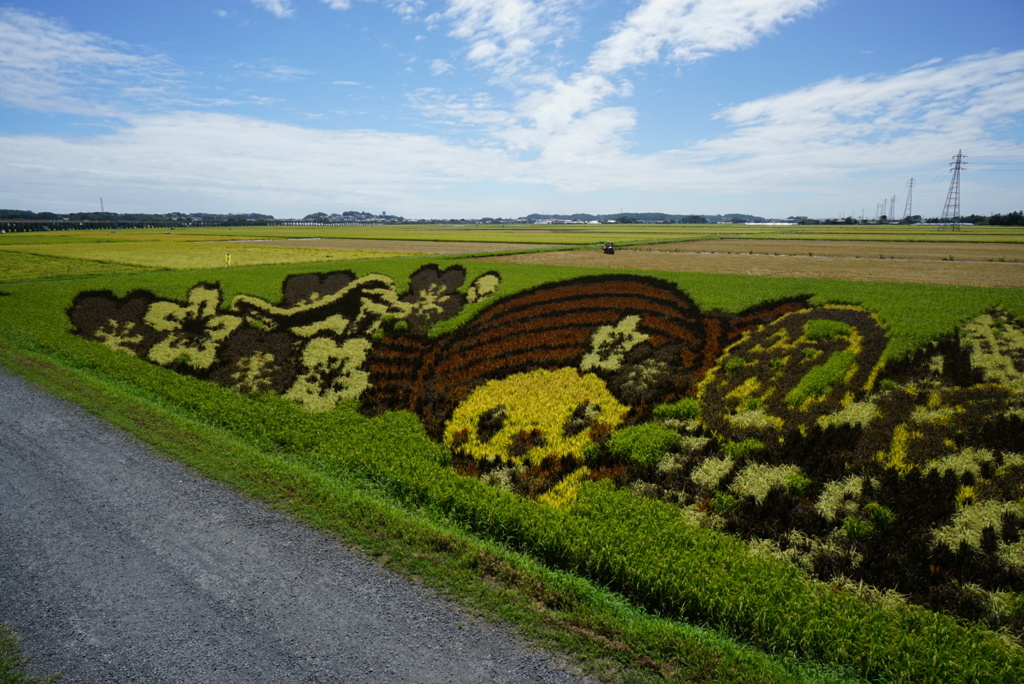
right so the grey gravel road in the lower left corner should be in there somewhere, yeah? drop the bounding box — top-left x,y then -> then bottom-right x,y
0,370 -> 581,684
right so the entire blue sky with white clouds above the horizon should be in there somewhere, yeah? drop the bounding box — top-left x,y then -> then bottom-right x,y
0,0 -> 1024,218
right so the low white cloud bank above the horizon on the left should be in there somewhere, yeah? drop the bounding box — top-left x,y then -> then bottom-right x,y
0,112 -> 528,216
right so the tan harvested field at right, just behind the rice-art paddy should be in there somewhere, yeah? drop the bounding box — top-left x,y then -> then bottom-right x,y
486,240 -> 1024,288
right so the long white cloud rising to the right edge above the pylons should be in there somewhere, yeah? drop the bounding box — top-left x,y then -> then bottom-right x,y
561,50 -> 1024,202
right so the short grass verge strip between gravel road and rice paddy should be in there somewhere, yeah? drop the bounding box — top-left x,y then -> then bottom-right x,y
0,343 -> 862,682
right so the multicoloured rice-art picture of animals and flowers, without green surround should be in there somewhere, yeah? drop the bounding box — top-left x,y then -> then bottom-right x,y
68,265 -> 1024,635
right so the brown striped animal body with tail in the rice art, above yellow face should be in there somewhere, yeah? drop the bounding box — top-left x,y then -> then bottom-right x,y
362,275 -> 807,439
